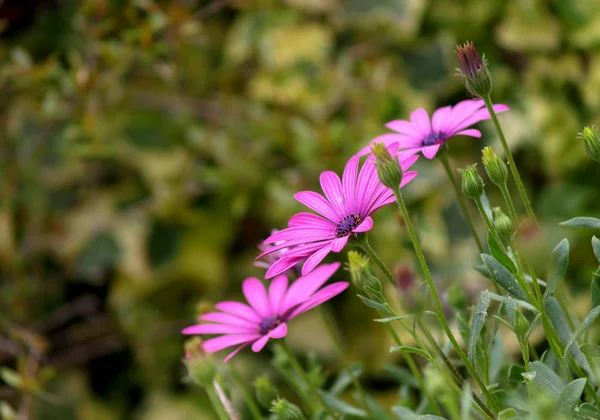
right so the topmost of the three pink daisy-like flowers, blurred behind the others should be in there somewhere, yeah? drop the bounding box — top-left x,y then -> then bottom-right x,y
358,99 -> 508,159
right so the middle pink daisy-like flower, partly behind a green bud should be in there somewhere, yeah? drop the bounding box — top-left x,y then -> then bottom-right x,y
257,144 -> 418,278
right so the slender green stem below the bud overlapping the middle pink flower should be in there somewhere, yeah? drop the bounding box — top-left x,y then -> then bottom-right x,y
394,188 -> 498,411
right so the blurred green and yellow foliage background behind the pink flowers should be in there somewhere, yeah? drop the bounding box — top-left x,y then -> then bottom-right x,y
0,0 -> 600,420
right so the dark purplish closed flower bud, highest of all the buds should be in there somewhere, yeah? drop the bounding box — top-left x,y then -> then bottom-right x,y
456,42 -> 492,99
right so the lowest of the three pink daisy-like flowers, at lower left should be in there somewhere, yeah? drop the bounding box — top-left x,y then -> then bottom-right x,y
182,263 -> 348,363
